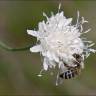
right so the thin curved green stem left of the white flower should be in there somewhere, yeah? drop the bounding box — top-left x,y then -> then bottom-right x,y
0,41 -> 32,51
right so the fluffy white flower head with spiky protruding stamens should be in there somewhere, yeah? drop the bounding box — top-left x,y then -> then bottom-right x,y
27,6 -> 96,85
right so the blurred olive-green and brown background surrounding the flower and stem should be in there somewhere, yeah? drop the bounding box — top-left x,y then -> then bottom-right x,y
0,0 -> 96,96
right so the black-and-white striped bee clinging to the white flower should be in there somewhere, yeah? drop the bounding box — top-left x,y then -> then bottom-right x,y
59,54 -> 82,79
